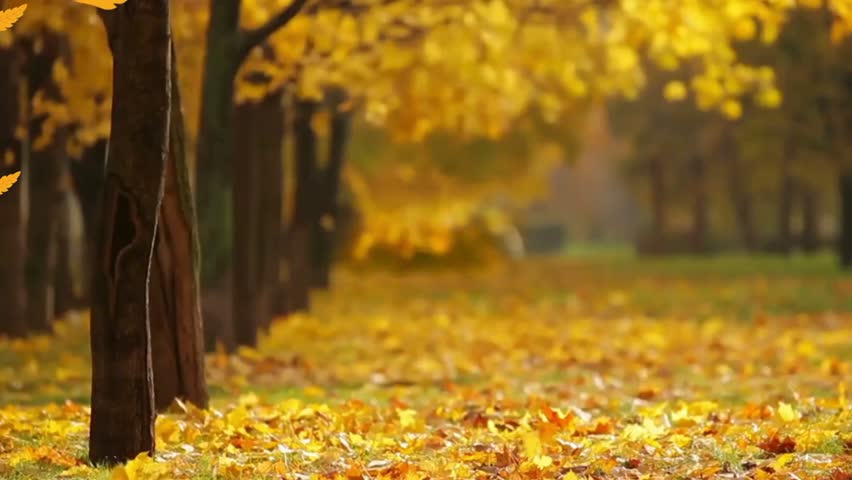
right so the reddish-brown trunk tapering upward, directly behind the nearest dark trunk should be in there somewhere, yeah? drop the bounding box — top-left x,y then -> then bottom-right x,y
150,45 -> 209,411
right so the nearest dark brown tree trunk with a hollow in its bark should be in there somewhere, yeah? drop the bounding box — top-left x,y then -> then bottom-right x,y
89,0 -> 171,464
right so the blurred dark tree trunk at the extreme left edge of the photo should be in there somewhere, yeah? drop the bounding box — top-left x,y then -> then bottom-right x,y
0,45 -> 27,337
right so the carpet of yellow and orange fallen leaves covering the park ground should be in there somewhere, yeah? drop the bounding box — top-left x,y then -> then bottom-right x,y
0,261 -> 852,480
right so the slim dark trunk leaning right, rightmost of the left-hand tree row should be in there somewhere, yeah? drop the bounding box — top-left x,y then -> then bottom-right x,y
312,94 -> 351,289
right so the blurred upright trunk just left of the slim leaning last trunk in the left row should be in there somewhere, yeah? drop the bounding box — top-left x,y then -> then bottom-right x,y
287,101 -> 320,313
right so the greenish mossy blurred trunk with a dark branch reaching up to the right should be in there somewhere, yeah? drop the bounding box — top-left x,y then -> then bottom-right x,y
195,0 -> 240,350
